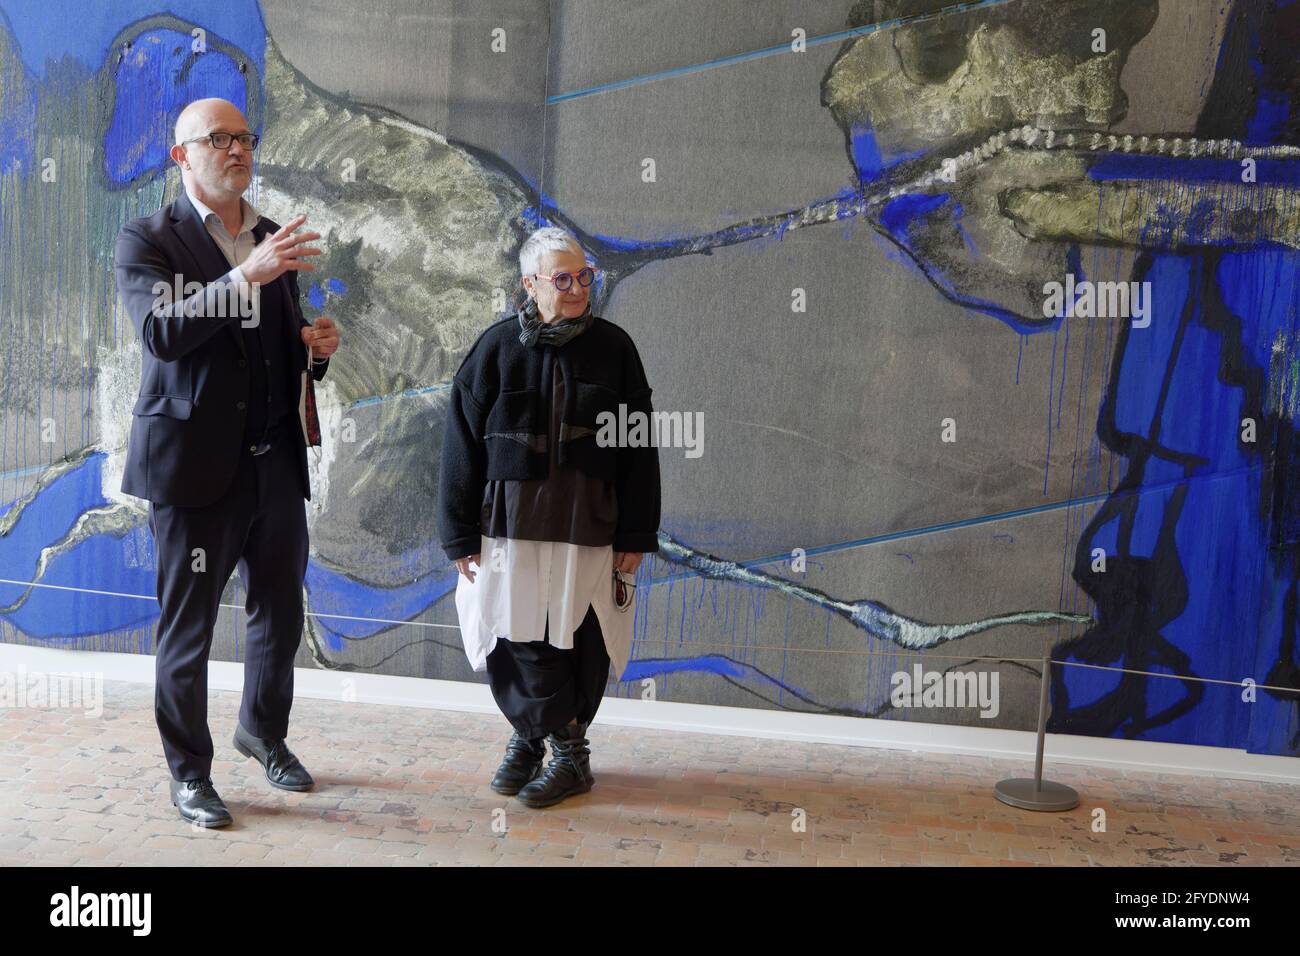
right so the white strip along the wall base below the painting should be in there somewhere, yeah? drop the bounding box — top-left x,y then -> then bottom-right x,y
0,644 -> 1300,787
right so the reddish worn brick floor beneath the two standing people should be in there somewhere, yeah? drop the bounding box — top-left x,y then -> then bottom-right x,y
0,682 -> 1300,866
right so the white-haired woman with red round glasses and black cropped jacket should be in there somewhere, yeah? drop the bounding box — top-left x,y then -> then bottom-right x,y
438,228 -> 659,806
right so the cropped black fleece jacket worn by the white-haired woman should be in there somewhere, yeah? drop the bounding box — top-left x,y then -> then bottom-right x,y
438,315 -> 659,561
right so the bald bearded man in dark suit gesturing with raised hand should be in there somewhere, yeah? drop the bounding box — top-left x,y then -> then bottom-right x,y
114,99 -> 339,827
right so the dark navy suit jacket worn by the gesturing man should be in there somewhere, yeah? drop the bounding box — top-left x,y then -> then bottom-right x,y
113,193 -> 328,507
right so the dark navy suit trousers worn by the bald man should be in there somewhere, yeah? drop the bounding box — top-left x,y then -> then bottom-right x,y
150,418 -> 308,780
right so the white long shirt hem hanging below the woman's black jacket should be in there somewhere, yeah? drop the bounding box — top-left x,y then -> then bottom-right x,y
456,535 -> 636,680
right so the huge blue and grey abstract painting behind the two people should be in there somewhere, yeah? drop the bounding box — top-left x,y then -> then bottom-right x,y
0,0 -> 1300,754
